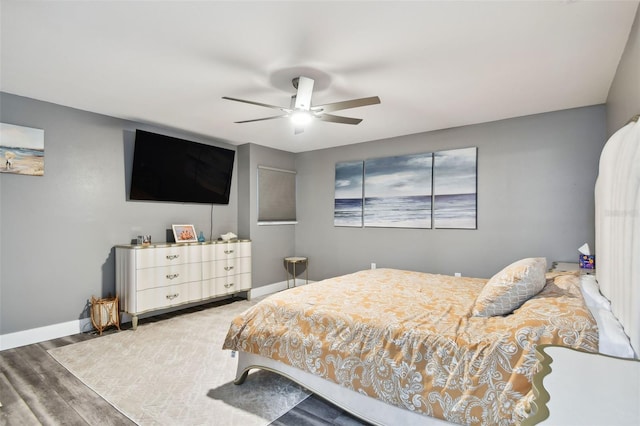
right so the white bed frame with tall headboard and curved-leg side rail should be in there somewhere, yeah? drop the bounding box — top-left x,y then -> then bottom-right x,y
235,119 -> 640,425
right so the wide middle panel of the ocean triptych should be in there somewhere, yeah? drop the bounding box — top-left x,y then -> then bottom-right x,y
364,152 -> 433,228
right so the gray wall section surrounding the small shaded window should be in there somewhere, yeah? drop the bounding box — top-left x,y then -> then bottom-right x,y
238,144 -> 299,288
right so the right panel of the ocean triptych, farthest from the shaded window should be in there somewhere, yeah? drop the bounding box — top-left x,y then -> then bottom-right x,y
433,147 -> 478,229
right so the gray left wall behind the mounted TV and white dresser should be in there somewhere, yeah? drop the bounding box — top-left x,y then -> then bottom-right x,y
0,93 -> 238,334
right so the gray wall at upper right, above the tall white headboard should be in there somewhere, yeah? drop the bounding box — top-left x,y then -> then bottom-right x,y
607,3 -> 640,136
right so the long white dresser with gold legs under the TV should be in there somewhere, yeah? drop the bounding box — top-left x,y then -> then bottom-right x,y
116,240 -> 251,329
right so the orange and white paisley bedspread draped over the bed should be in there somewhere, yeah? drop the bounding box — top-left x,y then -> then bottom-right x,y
223,269 -> 598,425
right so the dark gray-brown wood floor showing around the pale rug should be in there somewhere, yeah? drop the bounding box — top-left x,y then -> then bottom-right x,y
0,305 -> 366,426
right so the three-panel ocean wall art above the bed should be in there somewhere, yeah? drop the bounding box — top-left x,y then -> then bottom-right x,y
334,147 -> 478,229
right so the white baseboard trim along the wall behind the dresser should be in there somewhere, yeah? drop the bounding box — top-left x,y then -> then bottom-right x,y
0,280 -> 312,351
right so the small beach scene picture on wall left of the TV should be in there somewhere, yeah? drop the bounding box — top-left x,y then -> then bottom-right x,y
0,123 -> 44,176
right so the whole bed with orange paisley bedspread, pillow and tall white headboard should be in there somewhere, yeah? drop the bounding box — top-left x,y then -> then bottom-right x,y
223,117 -> 640,425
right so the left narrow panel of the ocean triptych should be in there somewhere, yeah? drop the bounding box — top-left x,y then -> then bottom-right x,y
333,161 -> 364,228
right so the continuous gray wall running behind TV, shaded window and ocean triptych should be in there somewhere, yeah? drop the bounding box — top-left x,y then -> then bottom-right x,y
0,100 -> 606,334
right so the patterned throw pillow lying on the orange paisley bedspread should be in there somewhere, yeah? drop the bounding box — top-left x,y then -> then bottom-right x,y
472,257 -> 547,317
